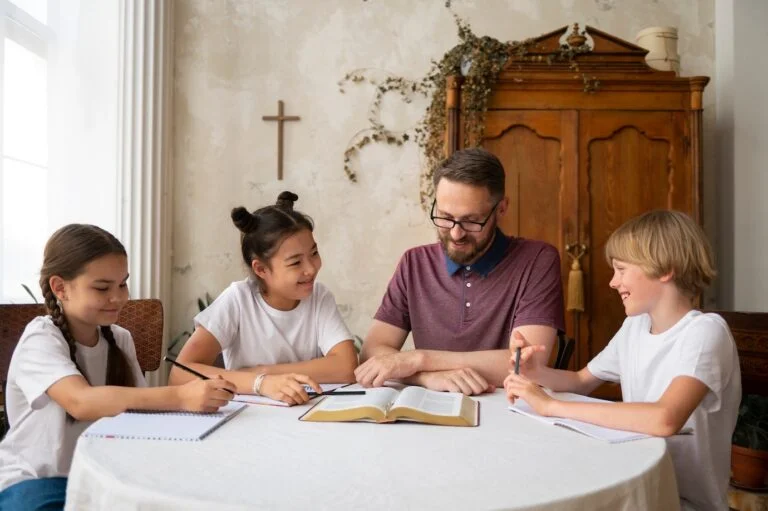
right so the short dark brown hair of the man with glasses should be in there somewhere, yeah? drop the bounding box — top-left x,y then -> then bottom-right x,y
432,147 -> 505,201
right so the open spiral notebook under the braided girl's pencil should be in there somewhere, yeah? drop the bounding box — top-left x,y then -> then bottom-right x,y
83,402 -> 247,442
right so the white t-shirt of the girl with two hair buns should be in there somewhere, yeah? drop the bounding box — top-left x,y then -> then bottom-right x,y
195,279 -> 352,370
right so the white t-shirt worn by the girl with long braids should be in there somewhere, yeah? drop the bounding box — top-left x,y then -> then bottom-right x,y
0,316 -> 146,491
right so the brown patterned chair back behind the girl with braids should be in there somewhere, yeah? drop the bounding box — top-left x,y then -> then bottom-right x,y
0,299 -> 163,382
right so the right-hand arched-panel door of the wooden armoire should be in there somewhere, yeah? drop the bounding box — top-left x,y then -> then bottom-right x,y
579,111 -> 695,365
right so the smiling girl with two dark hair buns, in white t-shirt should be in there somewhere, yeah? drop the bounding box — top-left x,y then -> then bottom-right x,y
170,192 -> 357,405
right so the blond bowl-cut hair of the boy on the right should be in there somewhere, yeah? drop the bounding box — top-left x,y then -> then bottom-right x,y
605,210 -> 717,297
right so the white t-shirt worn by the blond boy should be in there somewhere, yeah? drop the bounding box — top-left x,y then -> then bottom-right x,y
587,310 -> 741,510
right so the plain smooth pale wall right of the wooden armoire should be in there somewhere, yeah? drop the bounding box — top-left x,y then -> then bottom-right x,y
716,0 -> 768,311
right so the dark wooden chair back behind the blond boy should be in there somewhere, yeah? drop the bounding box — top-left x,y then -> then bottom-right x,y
707,310 -> 768,396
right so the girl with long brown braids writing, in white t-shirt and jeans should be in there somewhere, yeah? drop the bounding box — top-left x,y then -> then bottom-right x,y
0,224 -> 235,509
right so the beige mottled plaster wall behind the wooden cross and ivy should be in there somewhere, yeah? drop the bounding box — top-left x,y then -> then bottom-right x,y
171,0 -> 715,344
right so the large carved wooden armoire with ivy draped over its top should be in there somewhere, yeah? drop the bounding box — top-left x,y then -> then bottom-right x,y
446,27 -> 709,396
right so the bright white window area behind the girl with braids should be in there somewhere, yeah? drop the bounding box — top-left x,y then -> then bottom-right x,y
0,0 -> 119,303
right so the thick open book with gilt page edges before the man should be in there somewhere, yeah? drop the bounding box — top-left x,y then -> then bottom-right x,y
299,387 -> 480,426
